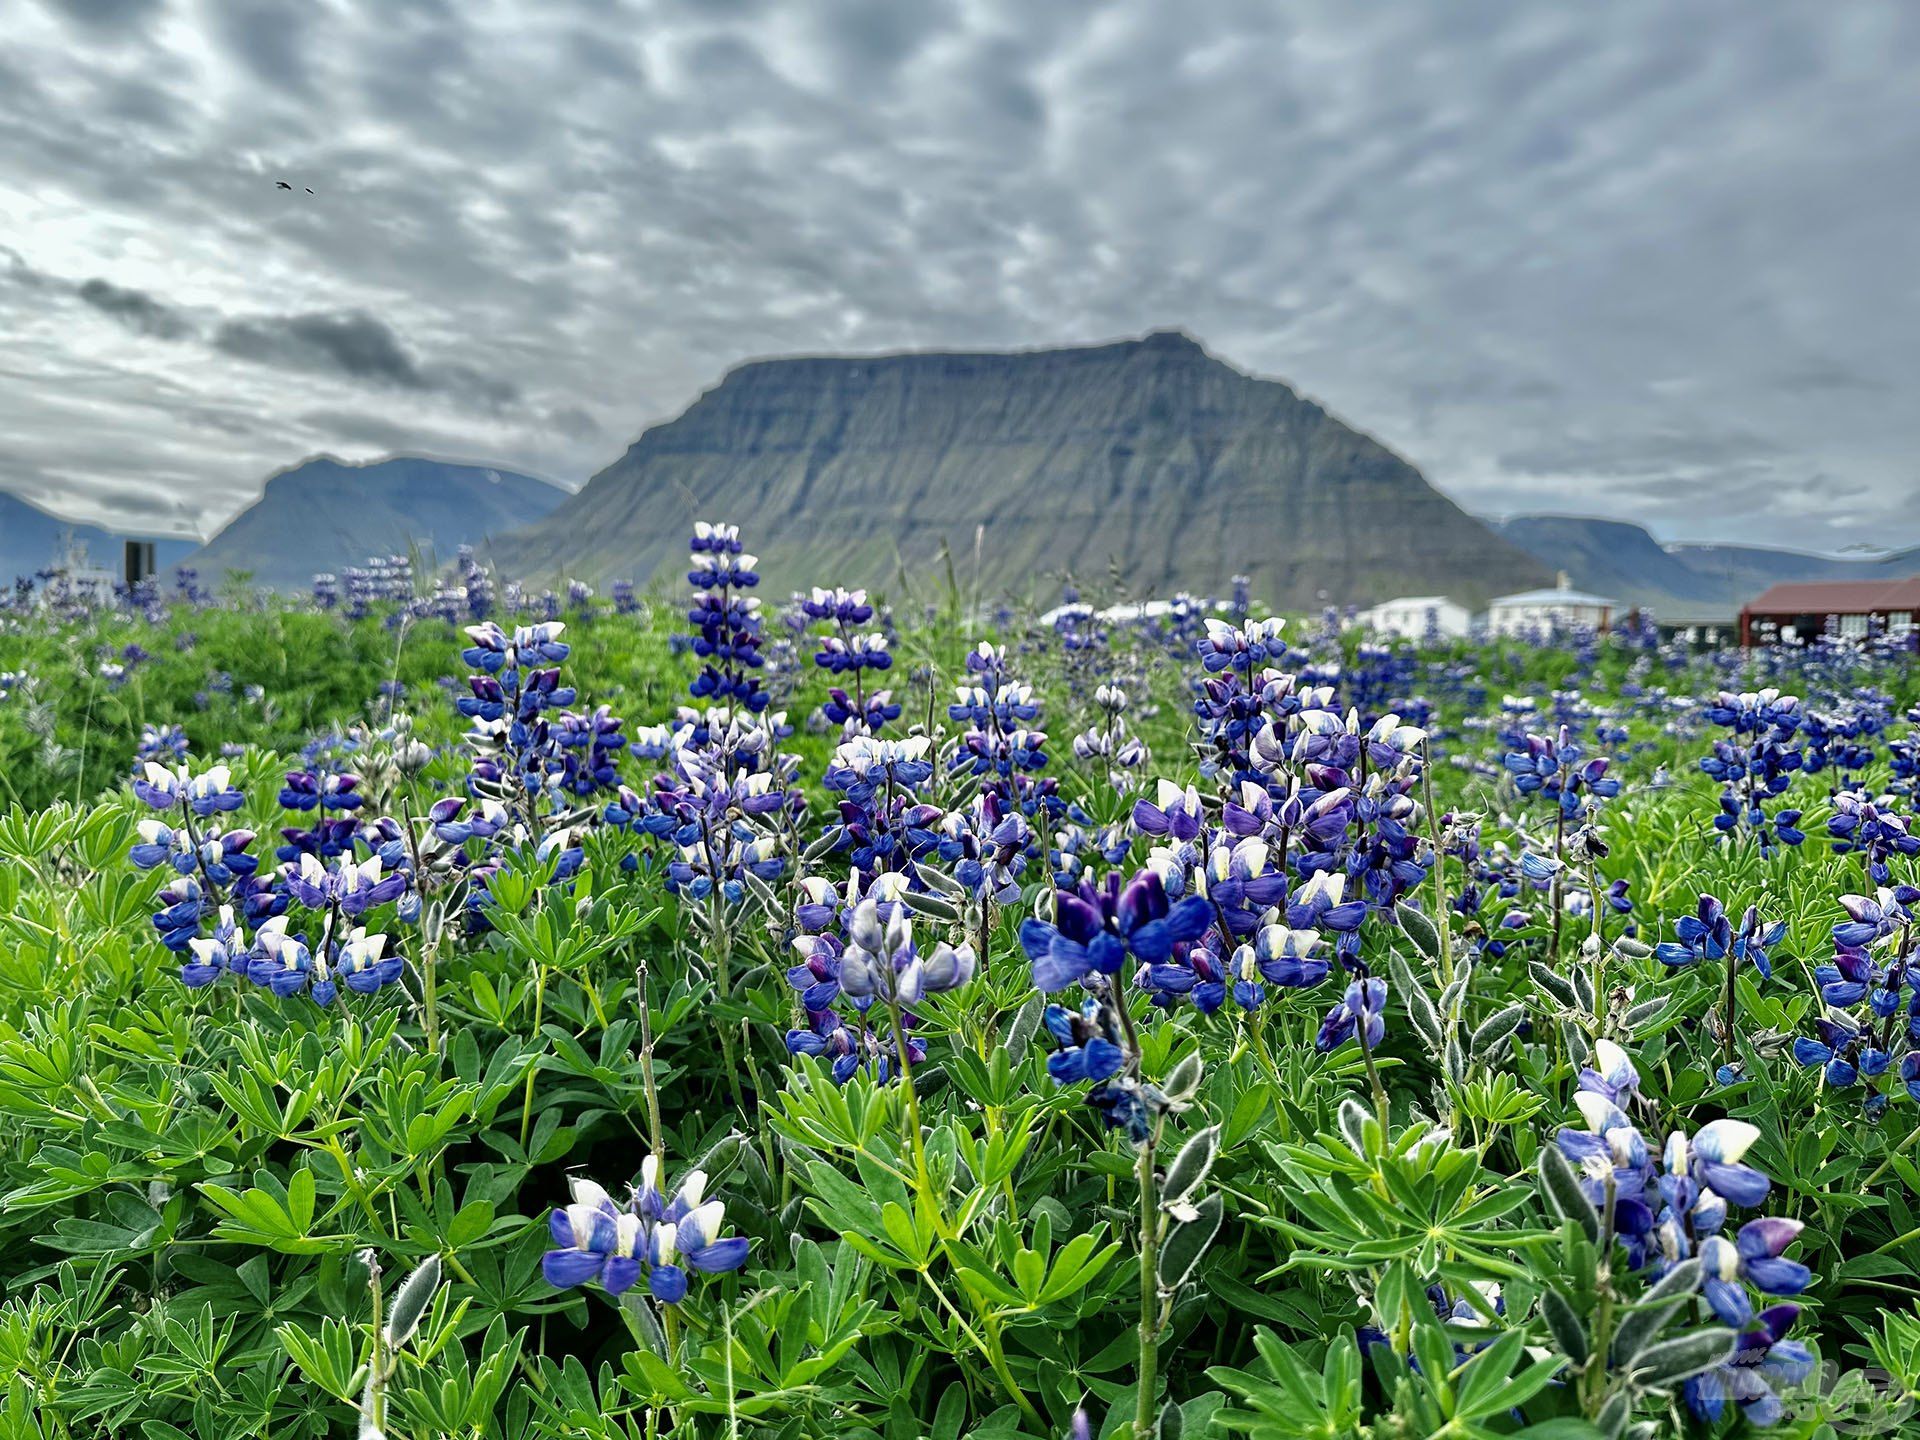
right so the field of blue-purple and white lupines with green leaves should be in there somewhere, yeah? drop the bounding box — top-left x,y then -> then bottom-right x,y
0,526 -> 1920,1440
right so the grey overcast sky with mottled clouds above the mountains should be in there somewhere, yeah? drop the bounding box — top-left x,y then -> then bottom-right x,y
0,0 -> 1920,549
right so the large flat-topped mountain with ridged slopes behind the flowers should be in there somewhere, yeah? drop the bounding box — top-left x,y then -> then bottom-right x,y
493,332 -> 1551,607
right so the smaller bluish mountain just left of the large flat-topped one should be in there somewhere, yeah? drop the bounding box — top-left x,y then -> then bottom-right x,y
192,455 -> 566,589
